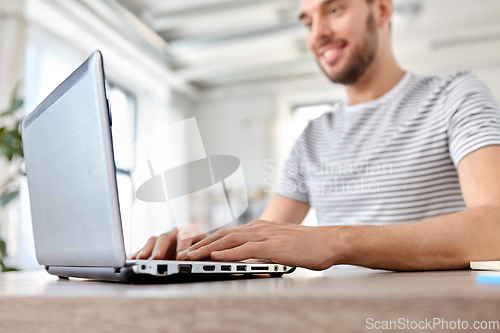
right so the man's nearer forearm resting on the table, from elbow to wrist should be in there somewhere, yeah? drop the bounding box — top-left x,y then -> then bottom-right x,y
332,205 -> 500,270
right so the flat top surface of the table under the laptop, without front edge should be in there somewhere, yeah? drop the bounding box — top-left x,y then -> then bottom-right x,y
0,266 -> 500,299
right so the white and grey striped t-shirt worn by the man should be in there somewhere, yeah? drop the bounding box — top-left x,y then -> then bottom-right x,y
277,72 -> 500,225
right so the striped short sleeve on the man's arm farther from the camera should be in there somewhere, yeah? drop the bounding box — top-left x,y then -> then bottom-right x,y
276,135 -> 309,202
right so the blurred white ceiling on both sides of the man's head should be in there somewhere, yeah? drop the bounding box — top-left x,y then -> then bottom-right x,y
110,0 -> 500,89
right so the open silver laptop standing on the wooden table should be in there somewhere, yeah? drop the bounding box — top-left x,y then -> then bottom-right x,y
22,51 -> 295,282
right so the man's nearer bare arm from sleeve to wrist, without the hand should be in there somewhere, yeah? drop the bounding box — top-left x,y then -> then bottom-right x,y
340,146 -> 500,270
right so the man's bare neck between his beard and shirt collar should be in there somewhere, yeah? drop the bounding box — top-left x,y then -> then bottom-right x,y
346,50 -> 405,105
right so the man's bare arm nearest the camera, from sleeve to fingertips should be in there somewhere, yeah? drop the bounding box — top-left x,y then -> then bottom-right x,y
179,146 -> 500,270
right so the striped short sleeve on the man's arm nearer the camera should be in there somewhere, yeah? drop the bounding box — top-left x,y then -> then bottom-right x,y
446,73 -> 500,167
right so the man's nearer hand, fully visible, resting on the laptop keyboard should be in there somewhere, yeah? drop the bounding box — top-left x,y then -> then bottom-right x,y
178,220 -> 336,270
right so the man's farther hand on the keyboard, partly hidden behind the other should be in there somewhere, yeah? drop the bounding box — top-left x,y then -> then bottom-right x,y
130,226 -> 208,260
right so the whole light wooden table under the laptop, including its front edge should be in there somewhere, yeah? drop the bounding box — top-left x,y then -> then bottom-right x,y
0,267 -> 500,333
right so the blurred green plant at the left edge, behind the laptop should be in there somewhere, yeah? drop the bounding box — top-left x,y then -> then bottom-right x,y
0,84 -> 25,272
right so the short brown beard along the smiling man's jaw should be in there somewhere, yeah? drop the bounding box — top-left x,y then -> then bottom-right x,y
320,14 -> 378,85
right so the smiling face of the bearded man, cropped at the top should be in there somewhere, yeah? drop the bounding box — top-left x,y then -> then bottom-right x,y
300,0 -> 379,85
